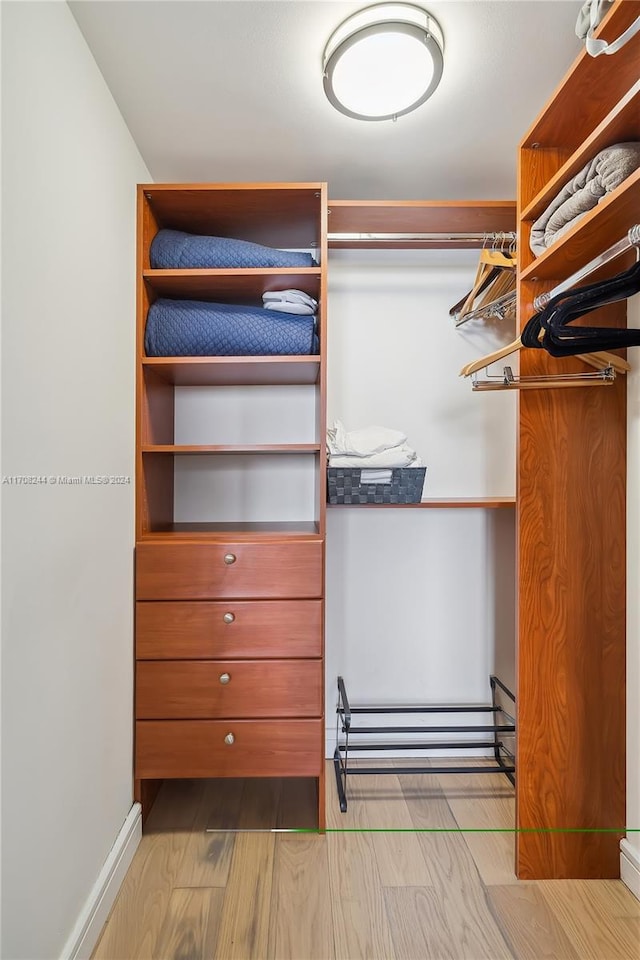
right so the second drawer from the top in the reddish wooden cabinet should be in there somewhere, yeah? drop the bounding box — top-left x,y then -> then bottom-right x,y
136,600 -> 322,660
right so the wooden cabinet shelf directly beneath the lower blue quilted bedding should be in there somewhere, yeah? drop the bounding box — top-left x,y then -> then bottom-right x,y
142,356 -> 320,387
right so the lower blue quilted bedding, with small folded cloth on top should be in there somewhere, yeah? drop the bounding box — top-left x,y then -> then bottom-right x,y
144,299 -> 318,357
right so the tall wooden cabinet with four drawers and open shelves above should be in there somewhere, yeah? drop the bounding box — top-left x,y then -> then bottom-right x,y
135,183 -> 327,828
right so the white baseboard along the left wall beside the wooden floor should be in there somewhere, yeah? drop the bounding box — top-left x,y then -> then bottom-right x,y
61,803 -> 142,960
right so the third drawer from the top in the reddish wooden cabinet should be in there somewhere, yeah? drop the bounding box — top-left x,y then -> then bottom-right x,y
136,660 -> 323,720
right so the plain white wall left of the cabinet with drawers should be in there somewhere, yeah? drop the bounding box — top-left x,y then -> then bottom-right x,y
2,3 -> 149,960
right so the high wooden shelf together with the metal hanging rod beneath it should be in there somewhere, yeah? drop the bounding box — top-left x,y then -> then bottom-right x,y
328,200 -> 516,249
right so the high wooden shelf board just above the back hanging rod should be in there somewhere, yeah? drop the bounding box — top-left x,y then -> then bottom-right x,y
329,200 -> 516,249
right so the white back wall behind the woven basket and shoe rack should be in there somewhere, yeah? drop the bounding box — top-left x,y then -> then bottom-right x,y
326,251 -> 516,754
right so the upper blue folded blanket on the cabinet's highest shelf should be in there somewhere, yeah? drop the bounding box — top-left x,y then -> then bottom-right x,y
149,230 -> 314,270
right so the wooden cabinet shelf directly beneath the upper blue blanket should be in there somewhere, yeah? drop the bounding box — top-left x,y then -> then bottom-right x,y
148,267 -> 320,306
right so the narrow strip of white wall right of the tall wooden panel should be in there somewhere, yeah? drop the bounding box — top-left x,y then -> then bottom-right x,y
622,295 -> 640,899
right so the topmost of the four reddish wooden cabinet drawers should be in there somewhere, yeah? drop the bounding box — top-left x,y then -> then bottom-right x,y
136,540 -> 323,600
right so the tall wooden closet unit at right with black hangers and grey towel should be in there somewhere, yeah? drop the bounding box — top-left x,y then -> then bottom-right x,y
516,0 -> 640,879
